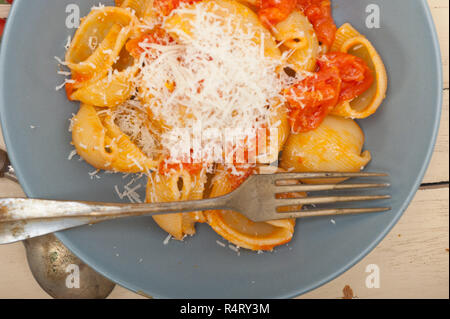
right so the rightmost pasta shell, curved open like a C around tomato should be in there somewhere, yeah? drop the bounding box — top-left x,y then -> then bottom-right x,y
331,24 -> 387,119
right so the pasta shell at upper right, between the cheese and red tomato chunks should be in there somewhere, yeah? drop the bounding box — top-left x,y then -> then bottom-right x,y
274,10 -> 319,72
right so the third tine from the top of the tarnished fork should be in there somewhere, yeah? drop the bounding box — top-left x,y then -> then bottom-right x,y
276,195 -> 391,207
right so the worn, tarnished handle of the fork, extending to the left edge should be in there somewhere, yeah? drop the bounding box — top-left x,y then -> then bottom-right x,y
0,196 -> 229,244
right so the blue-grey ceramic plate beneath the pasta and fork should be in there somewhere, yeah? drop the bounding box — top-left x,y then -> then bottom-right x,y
0,0 -> 442,298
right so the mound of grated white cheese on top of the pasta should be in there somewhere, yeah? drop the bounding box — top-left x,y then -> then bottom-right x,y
108,3 -> 294,174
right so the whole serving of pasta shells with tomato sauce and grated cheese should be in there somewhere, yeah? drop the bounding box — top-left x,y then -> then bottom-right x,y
61,0 -> 387,250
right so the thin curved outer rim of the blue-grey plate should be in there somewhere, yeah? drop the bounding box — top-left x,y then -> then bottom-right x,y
0,0 -> 443,299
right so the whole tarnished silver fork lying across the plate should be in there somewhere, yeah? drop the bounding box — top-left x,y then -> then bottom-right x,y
0,173 -> 390,244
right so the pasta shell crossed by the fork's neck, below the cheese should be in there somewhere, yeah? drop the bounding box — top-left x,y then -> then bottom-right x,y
146,170 -> 206,240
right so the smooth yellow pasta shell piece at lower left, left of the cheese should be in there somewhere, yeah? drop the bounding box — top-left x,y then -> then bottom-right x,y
72,104 -> 114,169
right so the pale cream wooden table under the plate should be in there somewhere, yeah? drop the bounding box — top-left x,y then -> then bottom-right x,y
0,0 -> 449,298
